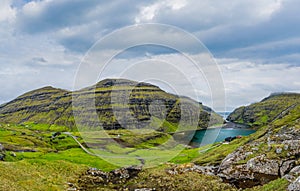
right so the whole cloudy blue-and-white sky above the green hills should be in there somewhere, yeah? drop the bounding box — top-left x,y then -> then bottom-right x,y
0,0 -> 300,111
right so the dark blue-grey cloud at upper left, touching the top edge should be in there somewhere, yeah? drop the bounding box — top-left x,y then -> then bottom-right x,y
16,0 -> 147,52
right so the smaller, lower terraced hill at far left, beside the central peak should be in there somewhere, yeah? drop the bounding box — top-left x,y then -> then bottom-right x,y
0,86 -> 74,127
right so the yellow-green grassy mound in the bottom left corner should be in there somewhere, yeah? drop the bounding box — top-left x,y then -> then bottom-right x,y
0,160 -> 86,191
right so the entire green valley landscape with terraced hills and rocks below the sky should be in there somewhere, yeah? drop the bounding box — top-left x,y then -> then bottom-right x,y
0,79 -> 300,191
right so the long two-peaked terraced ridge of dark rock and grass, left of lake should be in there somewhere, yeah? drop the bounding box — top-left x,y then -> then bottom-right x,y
0,79 -> 223,131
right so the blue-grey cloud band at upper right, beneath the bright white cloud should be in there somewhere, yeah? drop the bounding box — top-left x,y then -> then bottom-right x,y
199,0 -> 300,61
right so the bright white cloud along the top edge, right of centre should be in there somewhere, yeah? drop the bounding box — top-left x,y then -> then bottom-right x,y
135,0 -> 281,29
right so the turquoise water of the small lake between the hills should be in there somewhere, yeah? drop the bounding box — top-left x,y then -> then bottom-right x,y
192,128 -> 255,146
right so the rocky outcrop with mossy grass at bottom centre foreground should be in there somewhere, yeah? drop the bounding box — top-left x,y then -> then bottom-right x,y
74,163 -> 236,191
